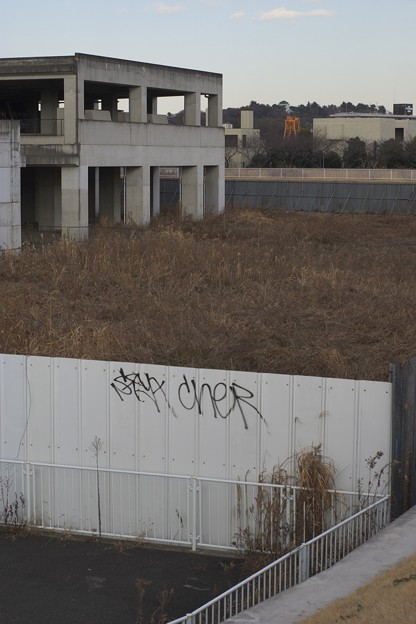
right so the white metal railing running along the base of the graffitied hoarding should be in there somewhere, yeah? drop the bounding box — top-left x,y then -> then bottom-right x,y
0,460 -> 386,552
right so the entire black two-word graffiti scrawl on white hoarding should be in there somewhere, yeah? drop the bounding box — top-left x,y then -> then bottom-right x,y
111,368 -> 264,429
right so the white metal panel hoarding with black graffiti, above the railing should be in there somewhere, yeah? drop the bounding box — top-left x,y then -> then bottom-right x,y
0,355 -> 391,490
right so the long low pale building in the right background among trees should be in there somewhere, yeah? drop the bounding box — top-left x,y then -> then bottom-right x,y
313,113 -> 416,143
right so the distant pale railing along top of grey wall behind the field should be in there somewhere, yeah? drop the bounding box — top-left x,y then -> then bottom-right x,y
225,167 -> 416,182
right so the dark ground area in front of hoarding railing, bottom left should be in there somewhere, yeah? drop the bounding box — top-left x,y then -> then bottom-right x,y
0,534 -> 244,624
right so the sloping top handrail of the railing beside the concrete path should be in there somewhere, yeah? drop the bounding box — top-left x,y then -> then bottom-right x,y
168,496 -> 390,624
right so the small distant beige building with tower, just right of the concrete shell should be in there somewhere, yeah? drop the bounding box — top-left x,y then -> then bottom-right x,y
224,110 -> 260,167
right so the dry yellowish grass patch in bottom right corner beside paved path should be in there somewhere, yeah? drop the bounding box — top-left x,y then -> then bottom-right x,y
302,556 -> 416,624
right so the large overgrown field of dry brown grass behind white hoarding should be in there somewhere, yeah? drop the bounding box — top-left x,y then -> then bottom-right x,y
0,210 -> 416,380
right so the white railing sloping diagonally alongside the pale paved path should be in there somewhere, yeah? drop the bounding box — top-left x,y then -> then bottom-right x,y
169,496 -> 389,624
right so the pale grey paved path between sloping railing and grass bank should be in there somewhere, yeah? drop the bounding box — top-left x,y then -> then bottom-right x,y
228,507 -> 416,624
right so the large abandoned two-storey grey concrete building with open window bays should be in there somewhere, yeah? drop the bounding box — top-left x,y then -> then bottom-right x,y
0,54 -> 224,247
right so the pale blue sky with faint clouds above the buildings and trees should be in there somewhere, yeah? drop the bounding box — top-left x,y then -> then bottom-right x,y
0,0 -> 416,113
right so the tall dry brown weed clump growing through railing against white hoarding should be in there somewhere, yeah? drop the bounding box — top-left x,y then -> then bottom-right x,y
236,444 -> 335,571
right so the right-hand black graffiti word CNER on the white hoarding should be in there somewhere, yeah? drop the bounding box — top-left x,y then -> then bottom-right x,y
178,375 -> 263,429
